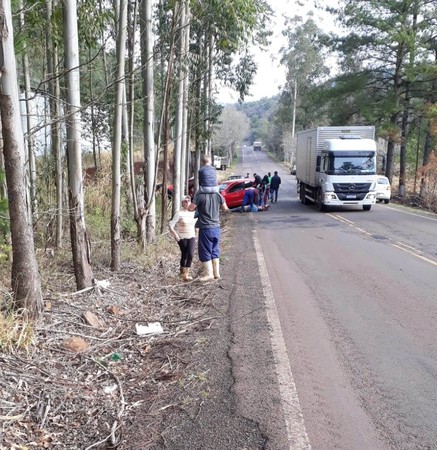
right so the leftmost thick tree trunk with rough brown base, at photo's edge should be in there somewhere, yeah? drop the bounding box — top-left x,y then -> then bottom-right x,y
0,1 -> 43,319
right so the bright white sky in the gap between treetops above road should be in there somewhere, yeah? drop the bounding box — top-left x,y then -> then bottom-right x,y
217,0 -> 333,104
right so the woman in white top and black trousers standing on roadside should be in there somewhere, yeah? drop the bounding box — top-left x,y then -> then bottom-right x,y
168,195 -> 197,281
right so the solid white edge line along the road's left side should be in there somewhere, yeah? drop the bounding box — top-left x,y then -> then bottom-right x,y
253,231 -> 311,450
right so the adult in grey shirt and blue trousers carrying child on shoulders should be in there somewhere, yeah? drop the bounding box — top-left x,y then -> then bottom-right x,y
188,182 -> 228,283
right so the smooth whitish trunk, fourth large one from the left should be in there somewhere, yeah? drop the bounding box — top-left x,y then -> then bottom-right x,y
140,0 -> 156,249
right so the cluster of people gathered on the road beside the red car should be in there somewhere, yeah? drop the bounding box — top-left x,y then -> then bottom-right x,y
239,171 -> 281,212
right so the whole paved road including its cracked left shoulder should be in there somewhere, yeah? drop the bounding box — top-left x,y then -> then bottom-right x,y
158,148 -> 437,450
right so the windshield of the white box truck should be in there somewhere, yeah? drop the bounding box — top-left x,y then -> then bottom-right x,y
325,152 -> 376,175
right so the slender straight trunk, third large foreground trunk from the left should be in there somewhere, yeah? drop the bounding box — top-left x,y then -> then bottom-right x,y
111,0 -> 127,271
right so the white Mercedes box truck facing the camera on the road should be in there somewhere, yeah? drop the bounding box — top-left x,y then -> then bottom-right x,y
296,126 -> 376,211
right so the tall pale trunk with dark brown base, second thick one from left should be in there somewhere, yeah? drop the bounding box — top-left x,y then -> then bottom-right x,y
63,0 -> 94,290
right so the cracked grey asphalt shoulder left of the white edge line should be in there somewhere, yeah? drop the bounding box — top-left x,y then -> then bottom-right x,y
154,209 -> 287,450
